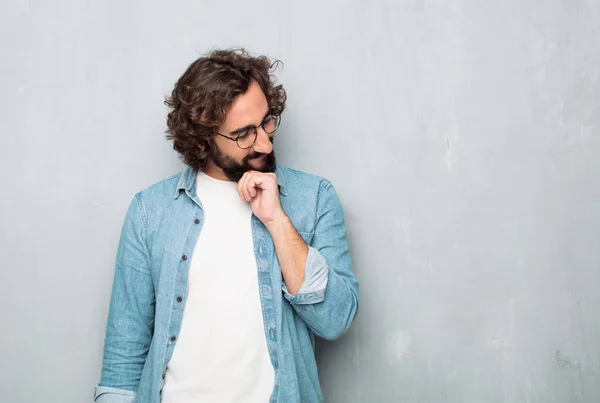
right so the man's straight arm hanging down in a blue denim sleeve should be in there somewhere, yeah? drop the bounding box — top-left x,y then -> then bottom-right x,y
94,193 -> 155,403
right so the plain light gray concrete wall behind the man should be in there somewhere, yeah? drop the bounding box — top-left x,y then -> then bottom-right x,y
0,0 -> 600,403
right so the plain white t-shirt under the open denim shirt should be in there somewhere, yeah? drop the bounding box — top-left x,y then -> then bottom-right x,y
162,171 -> 275,403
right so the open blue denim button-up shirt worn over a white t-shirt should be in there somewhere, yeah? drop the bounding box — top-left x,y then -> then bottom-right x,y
94,165 -> 358,403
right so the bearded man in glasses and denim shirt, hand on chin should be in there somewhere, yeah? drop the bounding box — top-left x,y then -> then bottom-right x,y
94,50 -> 358,403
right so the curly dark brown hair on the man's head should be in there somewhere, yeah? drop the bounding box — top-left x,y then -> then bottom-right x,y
165,49 -> 286,170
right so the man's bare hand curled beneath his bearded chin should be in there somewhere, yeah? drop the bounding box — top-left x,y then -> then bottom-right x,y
237,171 -> 286,226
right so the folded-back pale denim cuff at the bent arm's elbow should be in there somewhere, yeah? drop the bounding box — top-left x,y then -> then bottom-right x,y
282,246 -> 329,305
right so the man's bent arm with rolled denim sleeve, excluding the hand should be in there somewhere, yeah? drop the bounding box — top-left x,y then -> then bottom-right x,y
267,181 -> 358,340
